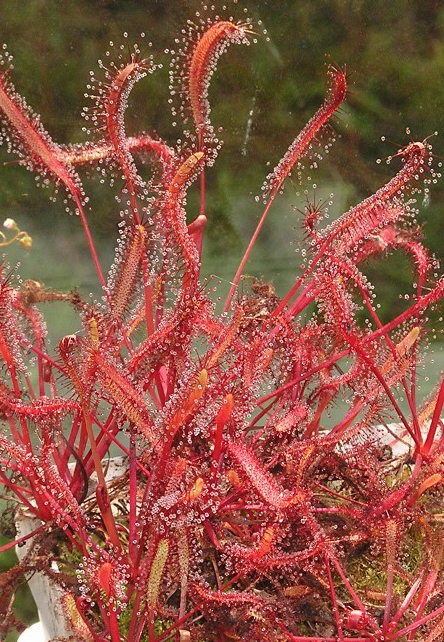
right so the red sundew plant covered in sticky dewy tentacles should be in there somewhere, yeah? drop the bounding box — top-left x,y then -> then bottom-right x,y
0,3 -> 444,642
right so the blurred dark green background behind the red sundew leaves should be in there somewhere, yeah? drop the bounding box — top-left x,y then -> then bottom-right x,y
0,0 -> 444,639
